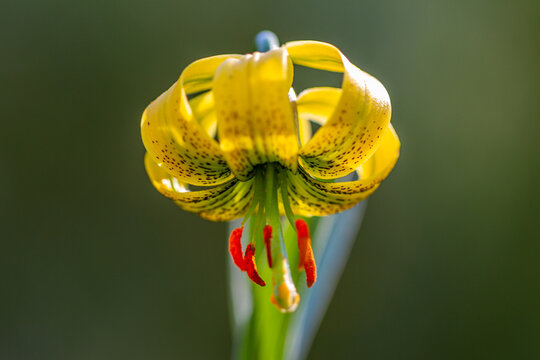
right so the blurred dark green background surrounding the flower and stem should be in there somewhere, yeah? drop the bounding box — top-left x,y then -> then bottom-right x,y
0,0 -> 540,360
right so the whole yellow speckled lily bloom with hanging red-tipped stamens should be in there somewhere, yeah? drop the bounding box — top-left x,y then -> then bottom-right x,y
141,41 -> 400,312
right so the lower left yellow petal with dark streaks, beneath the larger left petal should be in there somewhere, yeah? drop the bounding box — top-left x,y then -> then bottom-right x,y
144,153 -> 253,221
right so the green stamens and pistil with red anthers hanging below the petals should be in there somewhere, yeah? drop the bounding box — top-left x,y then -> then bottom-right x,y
229,163 -> 316,312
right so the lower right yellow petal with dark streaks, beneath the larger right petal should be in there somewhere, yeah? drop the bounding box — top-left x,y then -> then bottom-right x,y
288,124 -> 400,216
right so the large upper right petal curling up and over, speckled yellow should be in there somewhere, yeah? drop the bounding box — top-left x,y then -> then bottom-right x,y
285,41 -> 391,179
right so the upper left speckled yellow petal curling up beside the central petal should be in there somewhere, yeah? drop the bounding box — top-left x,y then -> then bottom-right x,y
141,55 -> 238,185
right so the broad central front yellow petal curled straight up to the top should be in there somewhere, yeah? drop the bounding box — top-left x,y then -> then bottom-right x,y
213,48 -> 298,180
